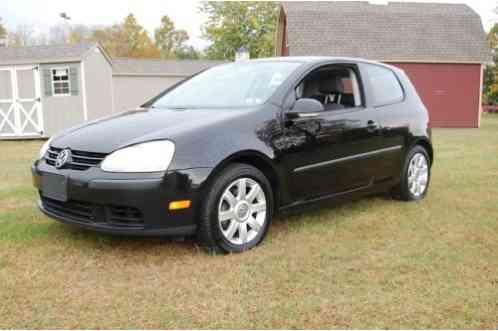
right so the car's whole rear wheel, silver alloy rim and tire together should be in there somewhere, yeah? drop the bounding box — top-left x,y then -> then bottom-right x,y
394,145 -> 431,201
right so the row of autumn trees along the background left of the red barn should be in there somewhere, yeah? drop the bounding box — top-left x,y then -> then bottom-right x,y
0,1 -> 279,60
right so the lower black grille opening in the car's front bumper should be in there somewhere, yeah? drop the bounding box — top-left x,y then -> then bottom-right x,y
41,196 -> 144,228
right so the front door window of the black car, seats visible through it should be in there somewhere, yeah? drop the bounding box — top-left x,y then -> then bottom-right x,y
295,65 -> 362,111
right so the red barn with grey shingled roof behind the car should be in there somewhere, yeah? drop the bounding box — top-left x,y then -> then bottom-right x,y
275,1 -> 491,128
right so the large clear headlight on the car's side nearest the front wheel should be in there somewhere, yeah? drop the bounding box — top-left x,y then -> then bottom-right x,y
101,140 -> 175,172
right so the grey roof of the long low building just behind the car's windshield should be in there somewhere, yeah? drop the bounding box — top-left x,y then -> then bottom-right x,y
112,58 -> 225,77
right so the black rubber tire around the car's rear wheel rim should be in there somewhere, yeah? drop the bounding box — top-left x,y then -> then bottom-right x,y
392,145 -> 431,201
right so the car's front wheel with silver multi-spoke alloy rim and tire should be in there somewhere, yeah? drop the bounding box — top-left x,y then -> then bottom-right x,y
197,164 -> 273,253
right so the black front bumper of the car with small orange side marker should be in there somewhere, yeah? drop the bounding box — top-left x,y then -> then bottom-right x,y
31,160 -> 211,236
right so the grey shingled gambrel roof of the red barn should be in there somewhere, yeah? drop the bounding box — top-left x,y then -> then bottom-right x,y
283,1 -> 491,63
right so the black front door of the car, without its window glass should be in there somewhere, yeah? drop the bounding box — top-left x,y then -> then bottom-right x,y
282,65 -> 381,201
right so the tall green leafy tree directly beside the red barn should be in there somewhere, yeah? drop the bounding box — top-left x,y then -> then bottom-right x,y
199,1 -> 279,60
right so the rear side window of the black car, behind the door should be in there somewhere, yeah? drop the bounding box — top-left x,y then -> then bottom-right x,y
366,64 -> 404,107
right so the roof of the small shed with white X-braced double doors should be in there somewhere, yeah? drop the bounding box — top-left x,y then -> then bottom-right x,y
0,43 -> 99,64
